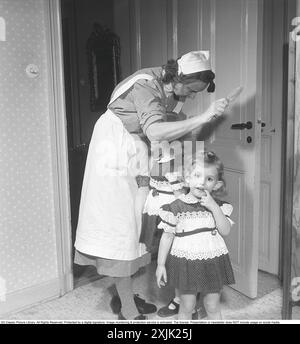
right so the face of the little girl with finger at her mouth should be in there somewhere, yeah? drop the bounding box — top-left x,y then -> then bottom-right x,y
186,164 -> 223,198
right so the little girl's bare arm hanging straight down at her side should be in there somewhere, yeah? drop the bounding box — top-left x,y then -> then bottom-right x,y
156,232 -> 175,288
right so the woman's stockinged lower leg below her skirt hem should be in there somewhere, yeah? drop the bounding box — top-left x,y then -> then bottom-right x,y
114,277 -> 139,319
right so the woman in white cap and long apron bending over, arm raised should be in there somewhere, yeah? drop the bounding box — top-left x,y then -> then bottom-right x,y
75,51 -> 227,320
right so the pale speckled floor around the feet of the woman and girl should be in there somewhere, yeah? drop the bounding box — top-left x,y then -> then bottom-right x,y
0,263 -> 300,321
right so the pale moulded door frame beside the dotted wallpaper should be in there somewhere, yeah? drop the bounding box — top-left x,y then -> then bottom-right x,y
44,0 -> 74,296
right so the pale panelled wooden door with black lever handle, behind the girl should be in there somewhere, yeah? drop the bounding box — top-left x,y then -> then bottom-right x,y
207,0 -> 262,298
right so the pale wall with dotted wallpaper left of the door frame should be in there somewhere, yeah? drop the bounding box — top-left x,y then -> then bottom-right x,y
0,0 -> 59,314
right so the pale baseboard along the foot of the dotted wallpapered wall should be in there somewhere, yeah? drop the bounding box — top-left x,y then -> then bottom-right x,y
0,278 -> 61,319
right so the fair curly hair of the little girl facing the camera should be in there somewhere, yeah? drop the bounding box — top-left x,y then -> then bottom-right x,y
184,151 -> 227,197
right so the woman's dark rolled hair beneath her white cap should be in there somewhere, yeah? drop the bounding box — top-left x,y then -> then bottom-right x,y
162,59 -> 216,93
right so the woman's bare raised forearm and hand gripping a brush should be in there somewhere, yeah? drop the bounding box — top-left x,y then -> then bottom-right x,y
146,98 -> 228,141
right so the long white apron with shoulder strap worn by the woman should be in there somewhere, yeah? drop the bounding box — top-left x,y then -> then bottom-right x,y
75,74 -> 153,261
